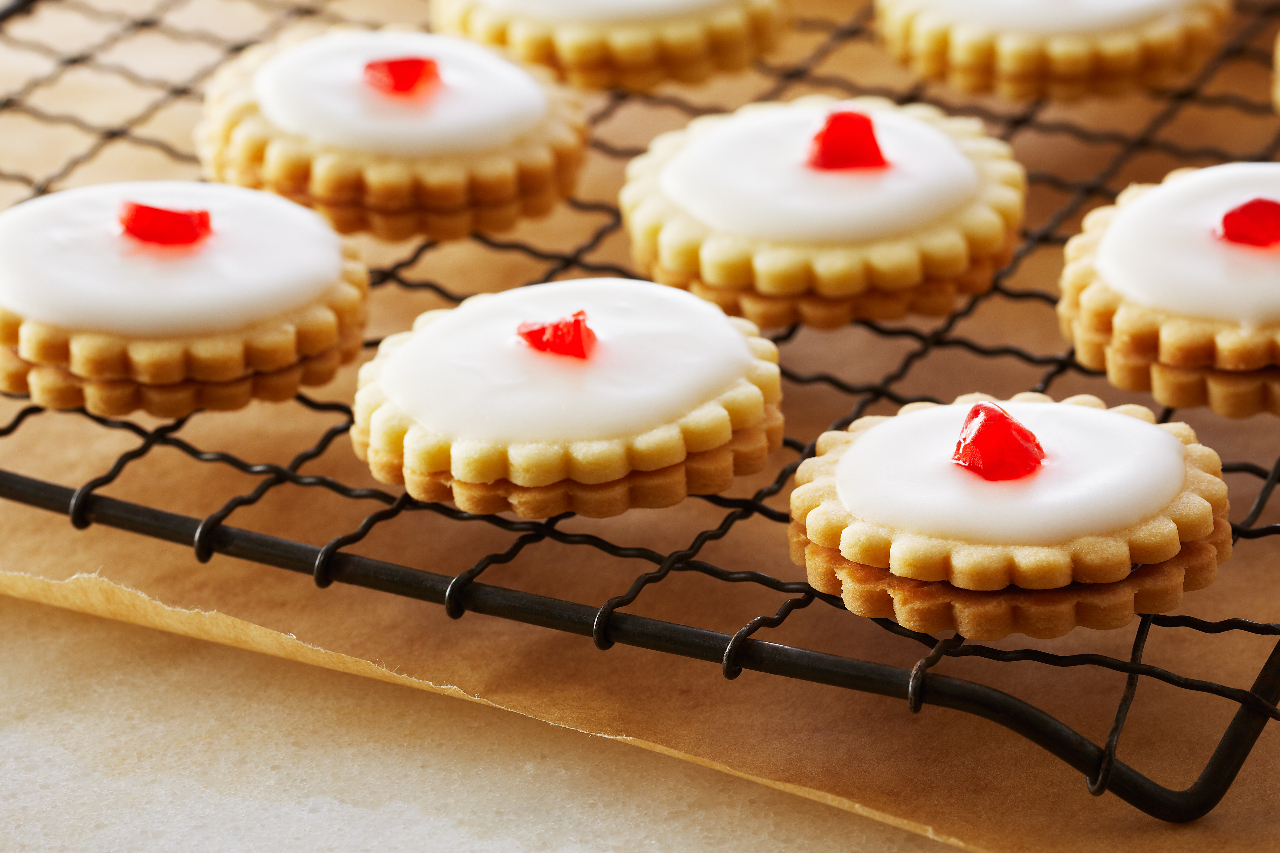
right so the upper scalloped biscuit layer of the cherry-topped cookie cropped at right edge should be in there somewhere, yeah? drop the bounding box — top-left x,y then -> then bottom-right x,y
1057,168 -> 1280,371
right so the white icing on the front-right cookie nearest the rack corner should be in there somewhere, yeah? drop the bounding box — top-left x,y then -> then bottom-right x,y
836,402 -> 1187,546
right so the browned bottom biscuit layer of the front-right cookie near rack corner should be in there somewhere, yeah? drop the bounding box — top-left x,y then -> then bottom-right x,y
788,519 -> 1231,642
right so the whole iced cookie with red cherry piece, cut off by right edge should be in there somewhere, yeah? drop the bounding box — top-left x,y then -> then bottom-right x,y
1057,163 -> 1280,418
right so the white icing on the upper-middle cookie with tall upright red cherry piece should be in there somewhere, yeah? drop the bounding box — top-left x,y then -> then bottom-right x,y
659,104 -> 979,242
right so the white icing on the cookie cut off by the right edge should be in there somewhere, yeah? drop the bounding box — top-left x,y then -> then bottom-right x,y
1094,163 -> 1280,327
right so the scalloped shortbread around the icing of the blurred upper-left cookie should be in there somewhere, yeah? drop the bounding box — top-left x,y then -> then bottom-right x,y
195,27 -> 589,240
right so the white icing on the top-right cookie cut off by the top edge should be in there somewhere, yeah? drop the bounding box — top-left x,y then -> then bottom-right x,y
902,0 -> 1193,36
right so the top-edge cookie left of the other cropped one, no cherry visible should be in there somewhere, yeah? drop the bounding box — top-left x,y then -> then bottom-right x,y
433,0 -> 786,88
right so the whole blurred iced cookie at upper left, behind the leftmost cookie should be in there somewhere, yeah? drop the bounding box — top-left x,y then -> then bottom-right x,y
196,29 -> 586,240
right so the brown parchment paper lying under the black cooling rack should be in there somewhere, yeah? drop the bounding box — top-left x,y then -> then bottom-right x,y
0,0 -> 1280,852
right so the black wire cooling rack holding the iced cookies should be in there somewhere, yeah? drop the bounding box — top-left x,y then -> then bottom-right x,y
0,0 -> 1280,821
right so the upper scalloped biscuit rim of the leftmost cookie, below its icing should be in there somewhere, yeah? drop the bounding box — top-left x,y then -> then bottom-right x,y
0,243 -> 369,386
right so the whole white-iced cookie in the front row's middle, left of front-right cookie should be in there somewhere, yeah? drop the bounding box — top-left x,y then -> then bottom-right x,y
351,279 -> 782,517
